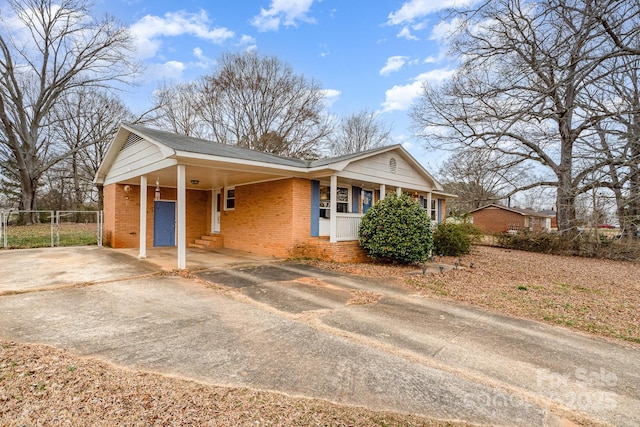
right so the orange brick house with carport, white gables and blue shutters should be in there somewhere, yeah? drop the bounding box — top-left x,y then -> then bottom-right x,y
94,124 -> 455,269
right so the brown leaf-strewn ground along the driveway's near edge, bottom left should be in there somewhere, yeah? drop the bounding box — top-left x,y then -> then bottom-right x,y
0,340 -> 469,426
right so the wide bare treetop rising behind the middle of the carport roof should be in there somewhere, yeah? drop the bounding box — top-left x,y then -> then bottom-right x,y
199,52 -> 331,158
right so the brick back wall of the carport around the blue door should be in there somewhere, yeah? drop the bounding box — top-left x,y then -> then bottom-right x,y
104,184 -> 211,248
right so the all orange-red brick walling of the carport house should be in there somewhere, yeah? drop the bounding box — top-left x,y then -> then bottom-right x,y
104,178 -> 369,262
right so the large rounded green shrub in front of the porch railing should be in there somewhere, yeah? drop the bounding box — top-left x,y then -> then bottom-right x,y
359,194 -> 433,264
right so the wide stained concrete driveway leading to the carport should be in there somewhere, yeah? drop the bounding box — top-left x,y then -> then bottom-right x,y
0,248 -> 640,426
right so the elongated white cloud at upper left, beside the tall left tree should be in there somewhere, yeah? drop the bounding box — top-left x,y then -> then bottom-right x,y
129,10 -> 234,59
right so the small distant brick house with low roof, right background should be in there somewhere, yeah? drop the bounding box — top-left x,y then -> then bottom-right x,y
469,204 -> 552,234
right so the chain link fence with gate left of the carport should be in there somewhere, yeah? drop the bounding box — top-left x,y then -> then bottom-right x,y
0,210 -> 103,249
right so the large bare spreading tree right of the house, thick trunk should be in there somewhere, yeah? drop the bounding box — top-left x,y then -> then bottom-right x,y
411,0 -> 628,233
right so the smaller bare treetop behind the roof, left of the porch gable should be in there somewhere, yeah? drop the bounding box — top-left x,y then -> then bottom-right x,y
330,110 -> 392,156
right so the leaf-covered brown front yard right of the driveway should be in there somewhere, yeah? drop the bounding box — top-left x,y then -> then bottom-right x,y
304,246 -> 640,344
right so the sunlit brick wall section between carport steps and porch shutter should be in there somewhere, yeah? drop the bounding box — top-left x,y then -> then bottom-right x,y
220,178 -> 311,258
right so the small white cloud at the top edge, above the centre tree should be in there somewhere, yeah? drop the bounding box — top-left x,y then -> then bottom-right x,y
251,0 -> 315,31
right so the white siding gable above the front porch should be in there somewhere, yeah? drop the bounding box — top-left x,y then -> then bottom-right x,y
345,152 -> 432,187
